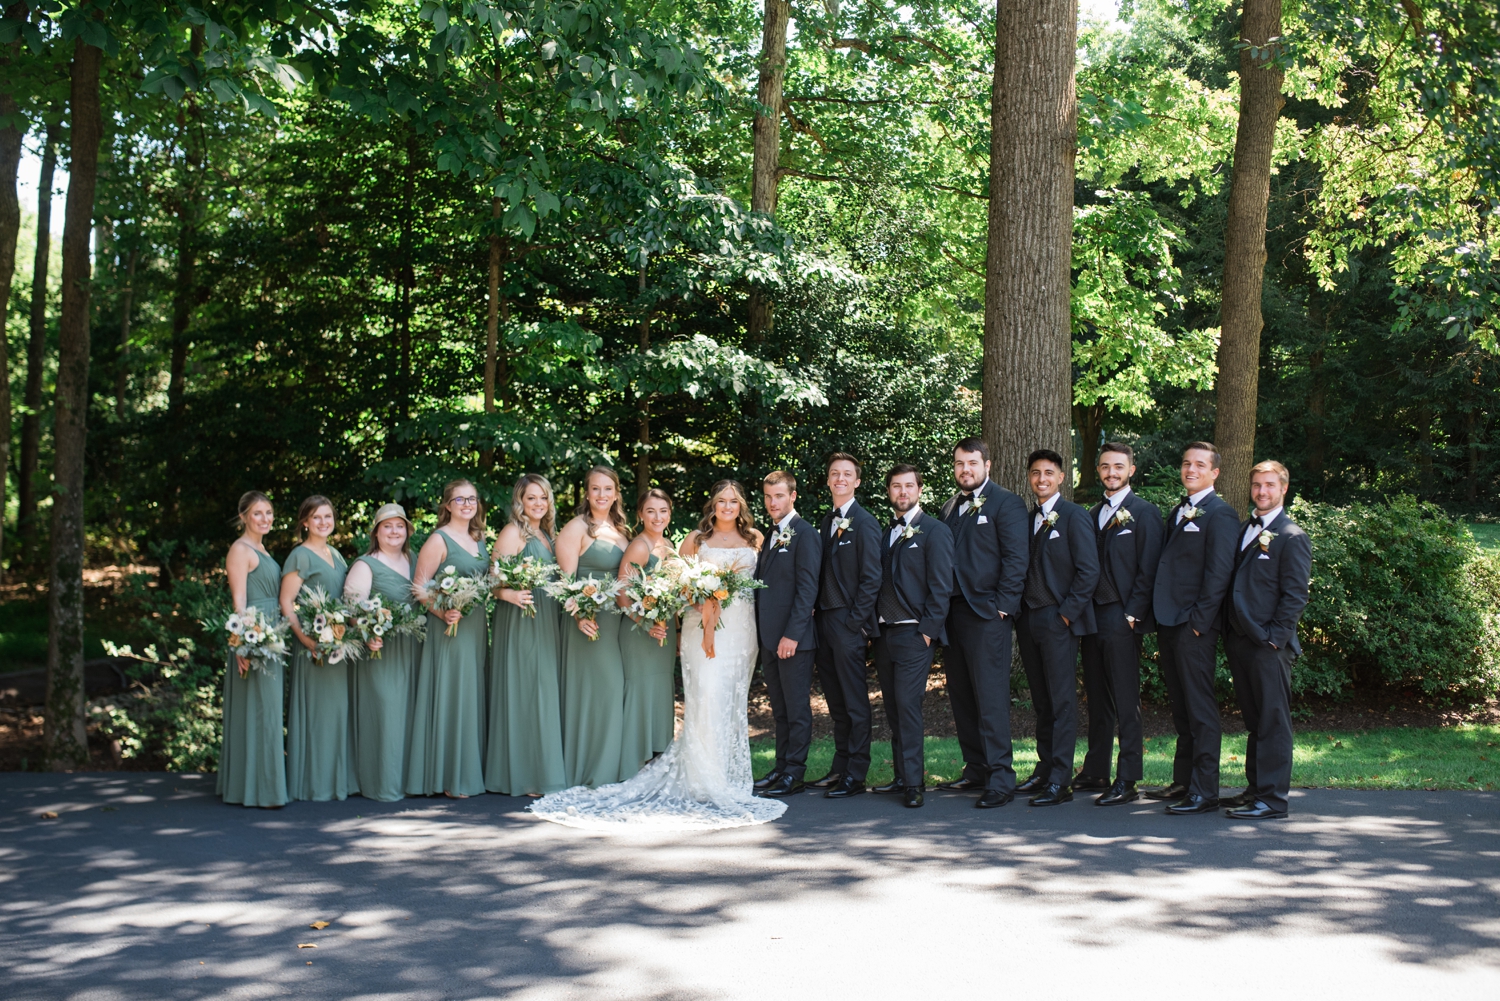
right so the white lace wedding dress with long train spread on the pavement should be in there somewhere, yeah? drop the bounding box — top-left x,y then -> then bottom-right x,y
531,546 -> 786,830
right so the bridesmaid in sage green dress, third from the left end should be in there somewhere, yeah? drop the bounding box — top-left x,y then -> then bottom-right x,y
344,504 -> 422,803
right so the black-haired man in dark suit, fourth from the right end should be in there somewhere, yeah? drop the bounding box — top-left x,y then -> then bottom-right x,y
1016,449 -> 1100,806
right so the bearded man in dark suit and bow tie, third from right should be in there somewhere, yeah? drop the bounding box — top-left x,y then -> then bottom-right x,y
1073,441 -> 1161,806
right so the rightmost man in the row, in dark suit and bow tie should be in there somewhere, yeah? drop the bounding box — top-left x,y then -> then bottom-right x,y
1224,462 -> 1313,821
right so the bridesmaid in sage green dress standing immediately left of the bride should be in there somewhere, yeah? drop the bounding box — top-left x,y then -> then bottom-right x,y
620,488 -> 677,771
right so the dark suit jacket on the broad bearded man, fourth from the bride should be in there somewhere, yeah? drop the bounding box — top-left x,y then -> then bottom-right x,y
942,480 -> 1031,618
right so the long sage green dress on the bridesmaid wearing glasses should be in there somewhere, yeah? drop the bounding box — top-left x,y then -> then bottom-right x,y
407,528 -> 489,795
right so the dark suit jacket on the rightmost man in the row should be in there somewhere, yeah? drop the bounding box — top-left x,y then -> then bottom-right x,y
1226,510 -> 1313,656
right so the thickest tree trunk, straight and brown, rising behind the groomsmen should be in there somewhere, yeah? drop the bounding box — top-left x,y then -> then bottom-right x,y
984,0 -> 1079,497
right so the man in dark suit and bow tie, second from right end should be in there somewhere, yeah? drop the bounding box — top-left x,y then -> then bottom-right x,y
1148,441 -> 1239,815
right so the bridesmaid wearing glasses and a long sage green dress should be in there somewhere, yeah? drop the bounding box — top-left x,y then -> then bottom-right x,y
407,480 -> 489,798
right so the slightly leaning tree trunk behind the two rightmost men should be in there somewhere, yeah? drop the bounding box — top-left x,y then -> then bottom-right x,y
1214,0 -> 1286,515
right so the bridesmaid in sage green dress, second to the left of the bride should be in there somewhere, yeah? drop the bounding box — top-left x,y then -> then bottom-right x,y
557,465 -> 639,785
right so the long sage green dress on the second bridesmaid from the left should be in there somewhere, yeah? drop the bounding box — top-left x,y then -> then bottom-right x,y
282,546 -> 360,803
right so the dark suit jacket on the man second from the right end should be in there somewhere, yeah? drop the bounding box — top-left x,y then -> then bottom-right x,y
1152,492 -> 1239,633
